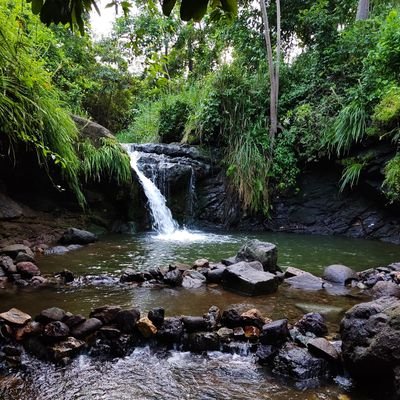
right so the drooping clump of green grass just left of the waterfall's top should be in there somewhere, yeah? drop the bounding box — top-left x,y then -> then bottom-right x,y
78,138 -> 132,185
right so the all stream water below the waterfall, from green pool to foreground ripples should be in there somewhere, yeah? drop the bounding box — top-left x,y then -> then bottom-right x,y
0,232 -> 400,400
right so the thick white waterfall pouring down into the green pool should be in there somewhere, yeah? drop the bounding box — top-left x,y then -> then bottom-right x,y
129,151 -> 179,235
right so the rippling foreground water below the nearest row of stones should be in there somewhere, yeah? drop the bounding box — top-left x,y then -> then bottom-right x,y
0,347 -> 365,400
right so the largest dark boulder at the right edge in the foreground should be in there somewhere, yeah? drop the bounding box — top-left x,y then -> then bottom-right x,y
340,297 -> 400,398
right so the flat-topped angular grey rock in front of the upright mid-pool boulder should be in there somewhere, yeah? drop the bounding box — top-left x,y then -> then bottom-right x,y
222,261 -> 279,296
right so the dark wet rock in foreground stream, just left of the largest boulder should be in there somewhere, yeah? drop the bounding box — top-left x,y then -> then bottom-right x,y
272,342 -> 331,381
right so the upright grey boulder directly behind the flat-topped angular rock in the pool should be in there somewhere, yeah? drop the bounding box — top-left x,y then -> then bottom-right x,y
236,239 -> 278,272
